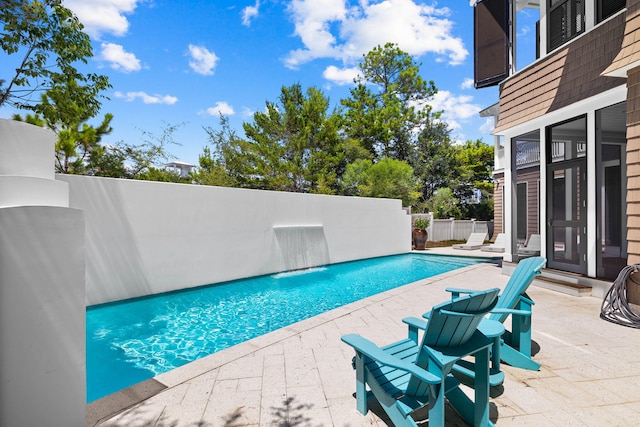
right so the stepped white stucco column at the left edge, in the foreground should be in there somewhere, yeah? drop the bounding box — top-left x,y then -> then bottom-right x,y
0,120 -> 86,427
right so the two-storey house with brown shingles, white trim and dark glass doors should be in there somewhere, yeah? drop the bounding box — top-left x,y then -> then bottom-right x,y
474,0 -> 640,280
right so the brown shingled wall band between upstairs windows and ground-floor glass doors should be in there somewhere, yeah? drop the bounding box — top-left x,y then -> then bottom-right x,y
494,14 -> 625,133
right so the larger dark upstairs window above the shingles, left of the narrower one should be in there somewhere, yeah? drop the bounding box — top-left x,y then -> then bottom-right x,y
549,0 -> 584,51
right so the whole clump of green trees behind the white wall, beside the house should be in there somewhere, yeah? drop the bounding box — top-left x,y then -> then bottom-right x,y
192,43 -> 493,219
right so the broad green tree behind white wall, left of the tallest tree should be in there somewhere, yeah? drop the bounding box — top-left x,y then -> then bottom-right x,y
205,84 -> 346,193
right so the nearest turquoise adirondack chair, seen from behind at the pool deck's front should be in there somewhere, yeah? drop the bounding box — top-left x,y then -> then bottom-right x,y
342,288 -> 500,427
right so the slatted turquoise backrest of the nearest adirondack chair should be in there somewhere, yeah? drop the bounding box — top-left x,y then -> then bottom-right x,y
422,288 -> 500,347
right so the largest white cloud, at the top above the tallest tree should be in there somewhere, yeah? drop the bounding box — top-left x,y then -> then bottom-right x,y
284,0 -> 469,69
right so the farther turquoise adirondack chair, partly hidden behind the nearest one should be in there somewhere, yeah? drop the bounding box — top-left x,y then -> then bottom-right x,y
442,257 -> 547,386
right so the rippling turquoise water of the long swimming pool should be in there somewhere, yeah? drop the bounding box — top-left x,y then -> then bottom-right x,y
87,254 -> 481,402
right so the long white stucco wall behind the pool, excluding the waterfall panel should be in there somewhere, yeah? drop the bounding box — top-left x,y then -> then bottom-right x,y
57,175 -> 411,305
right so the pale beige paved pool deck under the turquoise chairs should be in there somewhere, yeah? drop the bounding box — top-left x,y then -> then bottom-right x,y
87,249 -> 640,427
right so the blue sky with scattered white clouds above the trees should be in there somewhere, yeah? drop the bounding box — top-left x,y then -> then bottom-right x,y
0,0 -> 535,164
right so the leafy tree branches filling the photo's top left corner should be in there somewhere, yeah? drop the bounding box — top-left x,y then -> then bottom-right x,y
0,0 -> 110,112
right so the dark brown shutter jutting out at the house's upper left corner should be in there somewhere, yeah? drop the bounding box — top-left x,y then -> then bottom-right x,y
473,0 -> 510,88
